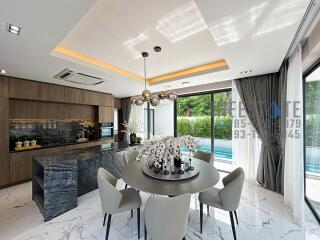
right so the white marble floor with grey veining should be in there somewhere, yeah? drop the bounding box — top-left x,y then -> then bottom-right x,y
0,176 -> 320,240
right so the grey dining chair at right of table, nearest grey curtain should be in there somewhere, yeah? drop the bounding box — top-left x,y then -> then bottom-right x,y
199,167 -> 245,240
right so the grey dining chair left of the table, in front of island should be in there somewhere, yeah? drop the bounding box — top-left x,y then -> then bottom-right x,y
97,167 -> 142,240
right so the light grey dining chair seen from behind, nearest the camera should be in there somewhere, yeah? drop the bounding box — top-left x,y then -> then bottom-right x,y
144,193 -> 191,240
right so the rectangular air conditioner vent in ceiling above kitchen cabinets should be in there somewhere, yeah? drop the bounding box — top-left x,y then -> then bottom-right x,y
54,68 -> 103,86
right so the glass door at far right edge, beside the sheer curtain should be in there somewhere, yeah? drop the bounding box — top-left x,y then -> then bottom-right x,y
304,65 -> 320,221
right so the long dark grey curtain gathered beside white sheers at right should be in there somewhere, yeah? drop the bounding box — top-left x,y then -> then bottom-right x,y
235,63 -> 287,193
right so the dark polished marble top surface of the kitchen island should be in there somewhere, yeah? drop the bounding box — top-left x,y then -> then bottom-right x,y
33,142 -> 139,167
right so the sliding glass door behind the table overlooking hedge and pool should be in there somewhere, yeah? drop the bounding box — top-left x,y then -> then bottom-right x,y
175,90 -> 232,166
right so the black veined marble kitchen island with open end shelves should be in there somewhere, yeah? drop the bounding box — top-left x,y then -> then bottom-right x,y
32,143 -> 140,221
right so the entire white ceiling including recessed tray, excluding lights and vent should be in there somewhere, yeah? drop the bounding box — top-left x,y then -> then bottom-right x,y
0,0 -> 309,97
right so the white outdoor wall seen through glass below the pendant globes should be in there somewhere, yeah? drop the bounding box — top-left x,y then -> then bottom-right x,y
154,102 -> 174,136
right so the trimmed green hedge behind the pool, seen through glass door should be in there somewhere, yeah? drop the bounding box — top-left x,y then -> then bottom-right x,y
177,115 -> 232,139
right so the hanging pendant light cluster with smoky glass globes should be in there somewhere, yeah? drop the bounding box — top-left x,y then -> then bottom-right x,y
130,46 -> 177,107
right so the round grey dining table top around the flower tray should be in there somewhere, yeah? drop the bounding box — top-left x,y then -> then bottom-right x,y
122,159 -> 220,196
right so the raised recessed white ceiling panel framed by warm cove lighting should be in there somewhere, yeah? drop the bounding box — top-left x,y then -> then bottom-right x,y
61,0 -> 223,78
